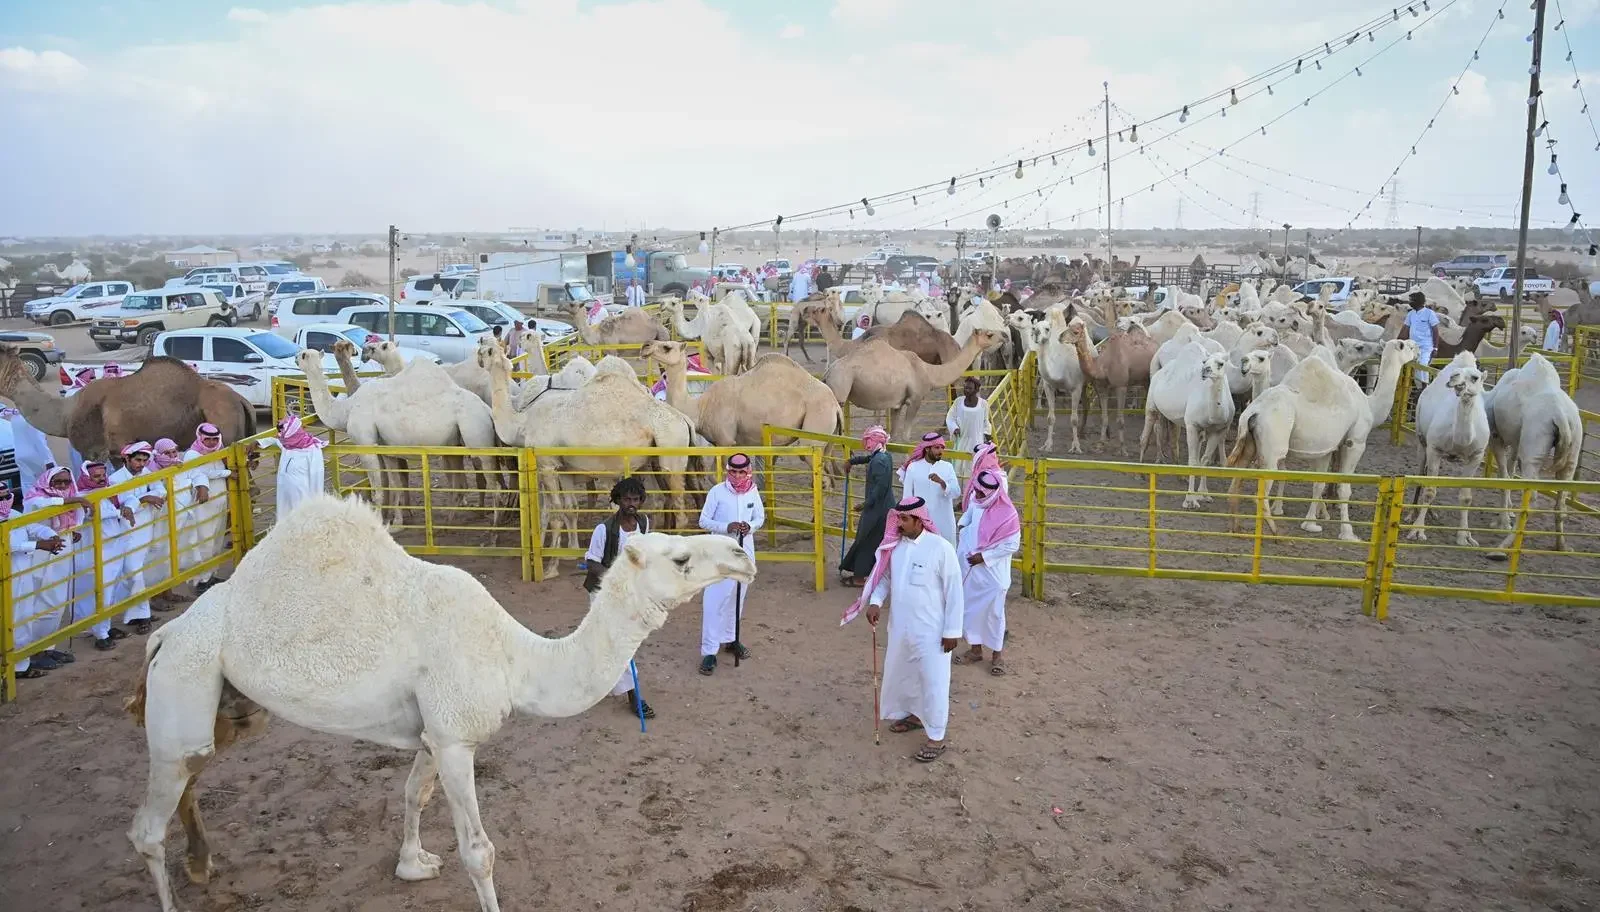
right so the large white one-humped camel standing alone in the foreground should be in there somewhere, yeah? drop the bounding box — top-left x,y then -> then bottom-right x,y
128,494 -> 755,912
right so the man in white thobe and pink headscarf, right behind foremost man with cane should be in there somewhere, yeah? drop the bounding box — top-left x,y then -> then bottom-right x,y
955,470 -> 1022,675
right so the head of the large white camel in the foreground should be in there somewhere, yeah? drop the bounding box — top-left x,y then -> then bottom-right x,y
614,533 -> 755,611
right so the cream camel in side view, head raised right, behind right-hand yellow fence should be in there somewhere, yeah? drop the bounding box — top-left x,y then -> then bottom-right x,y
1227,339 -> 1418,541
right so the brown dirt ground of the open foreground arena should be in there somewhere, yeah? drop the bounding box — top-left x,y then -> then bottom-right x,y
0,547 -> 1600,912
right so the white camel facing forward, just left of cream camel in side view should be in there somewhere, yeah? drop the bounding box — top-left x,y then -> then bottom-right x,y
1139,342 -> 1234,510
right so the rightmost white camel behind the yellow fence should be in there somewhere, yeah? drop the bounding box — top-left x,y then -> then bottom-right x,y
1483,352 -> 1584,560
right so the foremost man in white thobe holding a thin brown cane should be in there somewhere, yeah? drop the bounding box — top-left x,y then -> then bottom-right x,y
867,499 -> 963,763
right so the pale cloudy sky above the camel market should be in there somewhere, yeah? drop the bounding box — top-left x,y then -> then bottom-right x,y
0,0 -> 1600,237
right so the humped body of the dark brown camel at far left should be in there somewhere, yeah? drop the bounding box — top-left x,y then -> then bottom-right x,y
67,357 -> 256,459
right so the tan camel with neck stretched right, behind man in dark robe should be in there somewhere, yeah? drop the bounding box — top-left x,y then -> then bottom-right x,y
822,330 -> 1000,437
